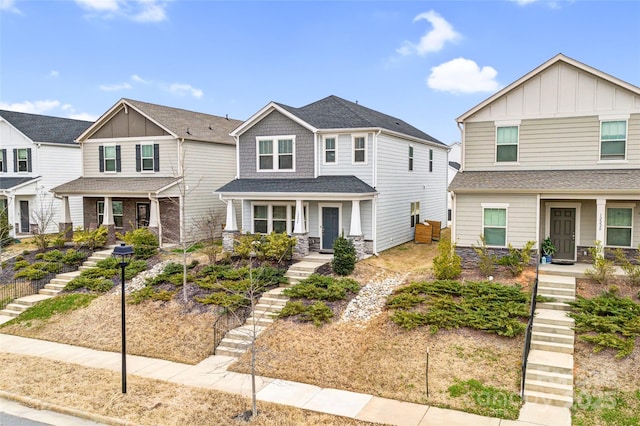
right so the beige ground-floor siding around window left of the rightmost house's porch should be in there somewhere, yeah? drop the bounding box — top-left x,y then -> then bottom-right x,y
455,194 -> 538,248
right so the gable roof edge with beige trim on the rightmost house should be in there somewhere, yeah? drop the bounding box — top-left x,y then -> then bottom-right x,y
456,53 -> 640,123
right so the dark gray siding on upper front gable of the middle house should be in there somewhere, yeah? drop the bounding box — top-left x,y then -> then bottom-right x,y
239,111 -> 314,179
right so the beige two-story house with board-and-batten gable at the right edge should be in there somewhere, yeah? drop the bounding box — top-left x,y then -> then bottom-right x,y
449,54 -> 640,262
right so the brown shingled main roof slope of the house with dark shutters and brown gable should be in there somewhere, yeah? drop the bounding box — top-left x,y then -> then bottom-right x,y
123,99 -> 242,145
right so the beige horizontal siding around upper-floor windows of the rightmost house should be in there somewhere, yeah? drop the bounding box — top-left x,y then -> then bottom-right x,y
464,114 -> 640,171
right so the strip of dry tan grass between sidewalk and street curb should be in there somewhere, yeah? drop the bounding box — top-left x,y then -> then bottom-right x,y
0,354 -> 372,426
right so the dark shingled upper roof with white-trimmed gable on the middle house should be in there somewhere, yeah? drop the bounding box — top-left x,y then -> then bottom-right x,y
232,95 -> 445,145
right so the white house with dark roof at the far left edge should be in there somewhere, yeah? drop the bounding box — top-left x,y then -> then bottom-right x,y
0,110 -> 91,237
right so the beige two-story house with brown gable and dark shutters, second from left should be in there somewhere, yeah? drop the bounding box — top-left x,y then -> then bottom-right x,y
53,99 -> 242,244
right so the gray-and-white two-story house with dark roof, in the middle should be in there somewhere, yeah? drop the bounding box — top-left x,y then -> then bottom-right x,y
217,96 -> 448,256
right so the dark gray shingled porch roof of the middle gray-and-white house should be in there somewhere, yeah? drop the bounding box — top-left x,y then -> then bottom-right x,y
216,176 -> 376,194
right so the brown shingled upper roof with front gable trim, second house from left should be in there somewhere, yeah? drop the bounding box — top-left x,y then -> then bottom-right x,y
78,98 -> 242,145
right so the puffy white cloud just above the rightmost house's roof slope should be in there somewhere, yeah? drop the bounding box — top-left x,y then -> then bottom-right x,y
427,58 -> 500,93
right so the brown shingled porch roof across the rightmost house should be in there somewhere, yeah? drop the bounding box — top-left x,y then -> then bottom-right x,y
449,169 -> 640,193
